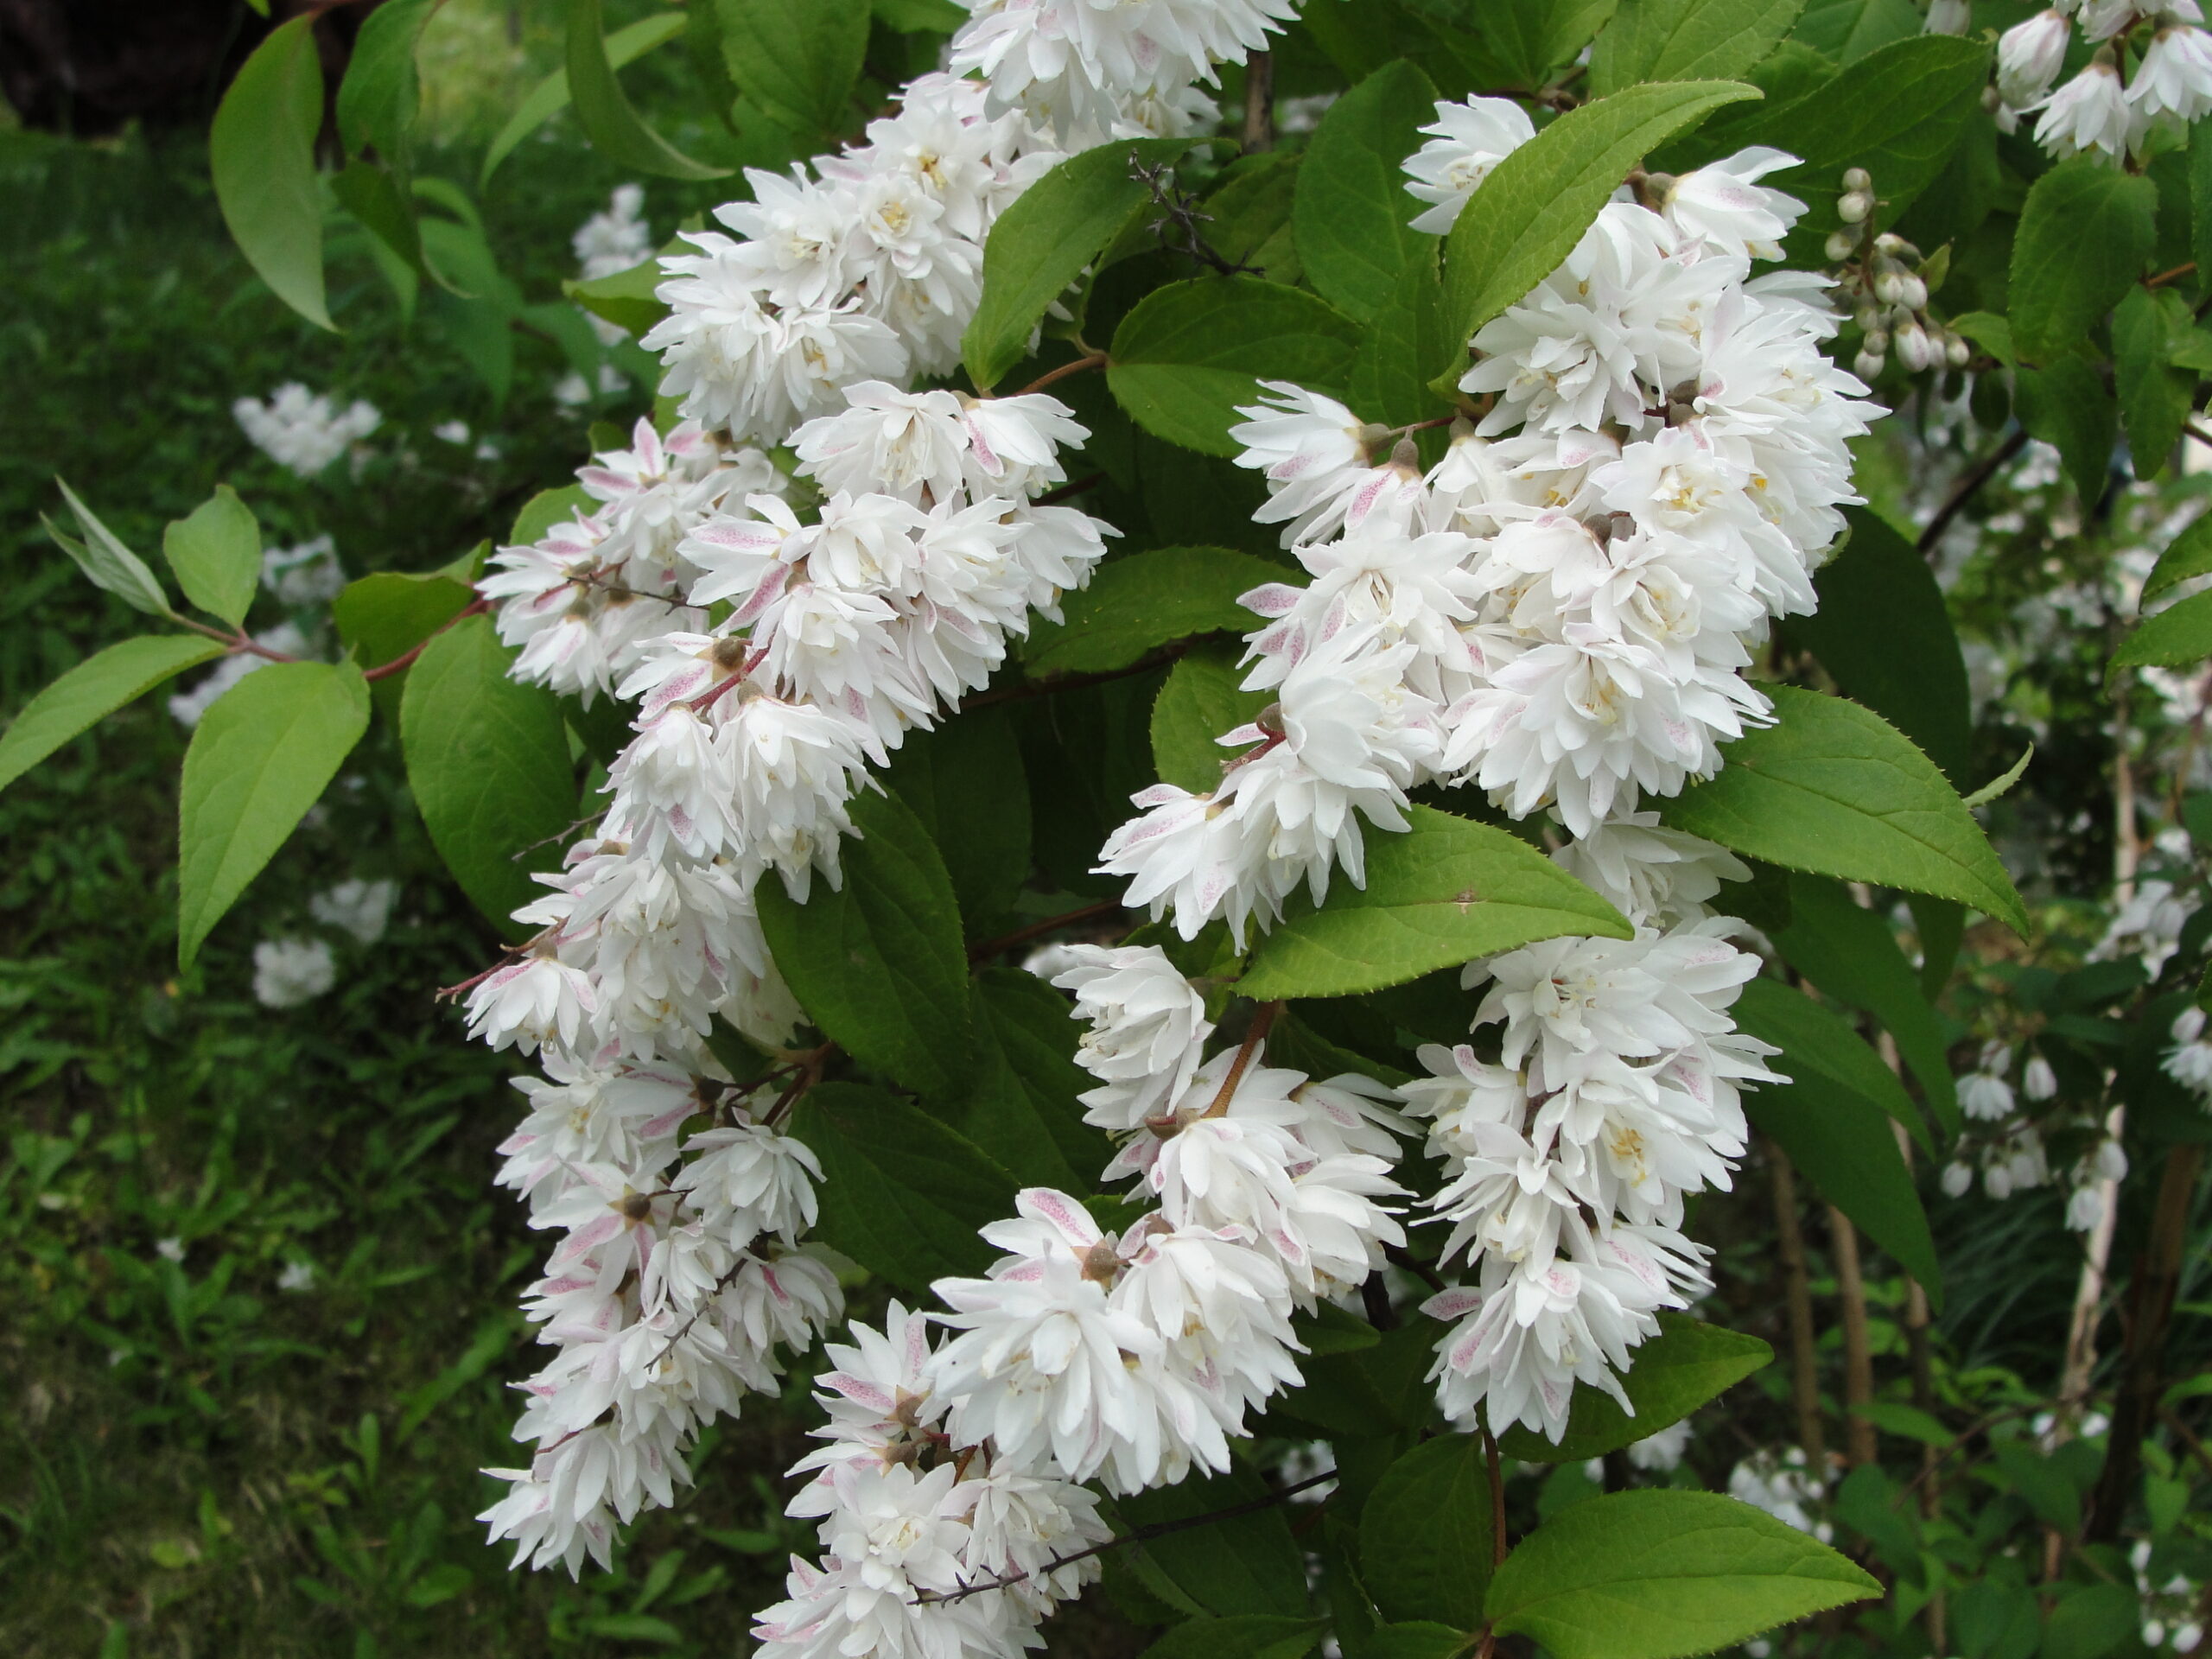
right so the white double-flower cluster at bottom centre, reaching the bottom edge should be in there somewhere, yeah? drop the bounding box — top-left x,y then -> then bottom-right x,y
754,947 -> 1405,1659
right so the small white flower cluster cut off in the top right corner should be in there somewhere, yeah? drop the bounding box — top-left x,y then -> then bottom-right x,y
1995,0 -> 2212,163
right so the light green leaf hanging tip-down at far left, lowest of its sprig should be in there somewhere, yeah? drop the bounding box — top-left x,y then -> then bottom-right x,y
177,661 -> 370,967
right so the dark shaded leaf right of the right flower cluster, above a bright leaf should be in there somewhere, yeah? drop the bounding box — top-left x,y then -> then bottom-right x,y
1787,506 -> 1974,787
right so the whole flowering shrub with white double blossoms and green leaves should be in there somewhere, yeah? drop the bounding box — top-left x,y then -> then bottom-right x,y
13,0 -> 2212,1659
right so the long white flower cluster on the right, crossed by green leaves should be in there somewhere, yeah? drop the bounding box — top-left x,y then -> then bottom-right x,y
1099,99 -> 1872,1435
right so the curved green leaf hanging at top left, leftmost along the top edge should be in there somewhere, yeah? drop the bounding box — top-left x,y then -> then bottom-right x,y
208,13 -> 336,332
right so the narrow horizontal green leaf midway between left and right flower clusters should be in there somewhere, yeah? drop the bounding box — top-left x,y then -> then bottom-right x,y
1022,546 -> 1283,677
